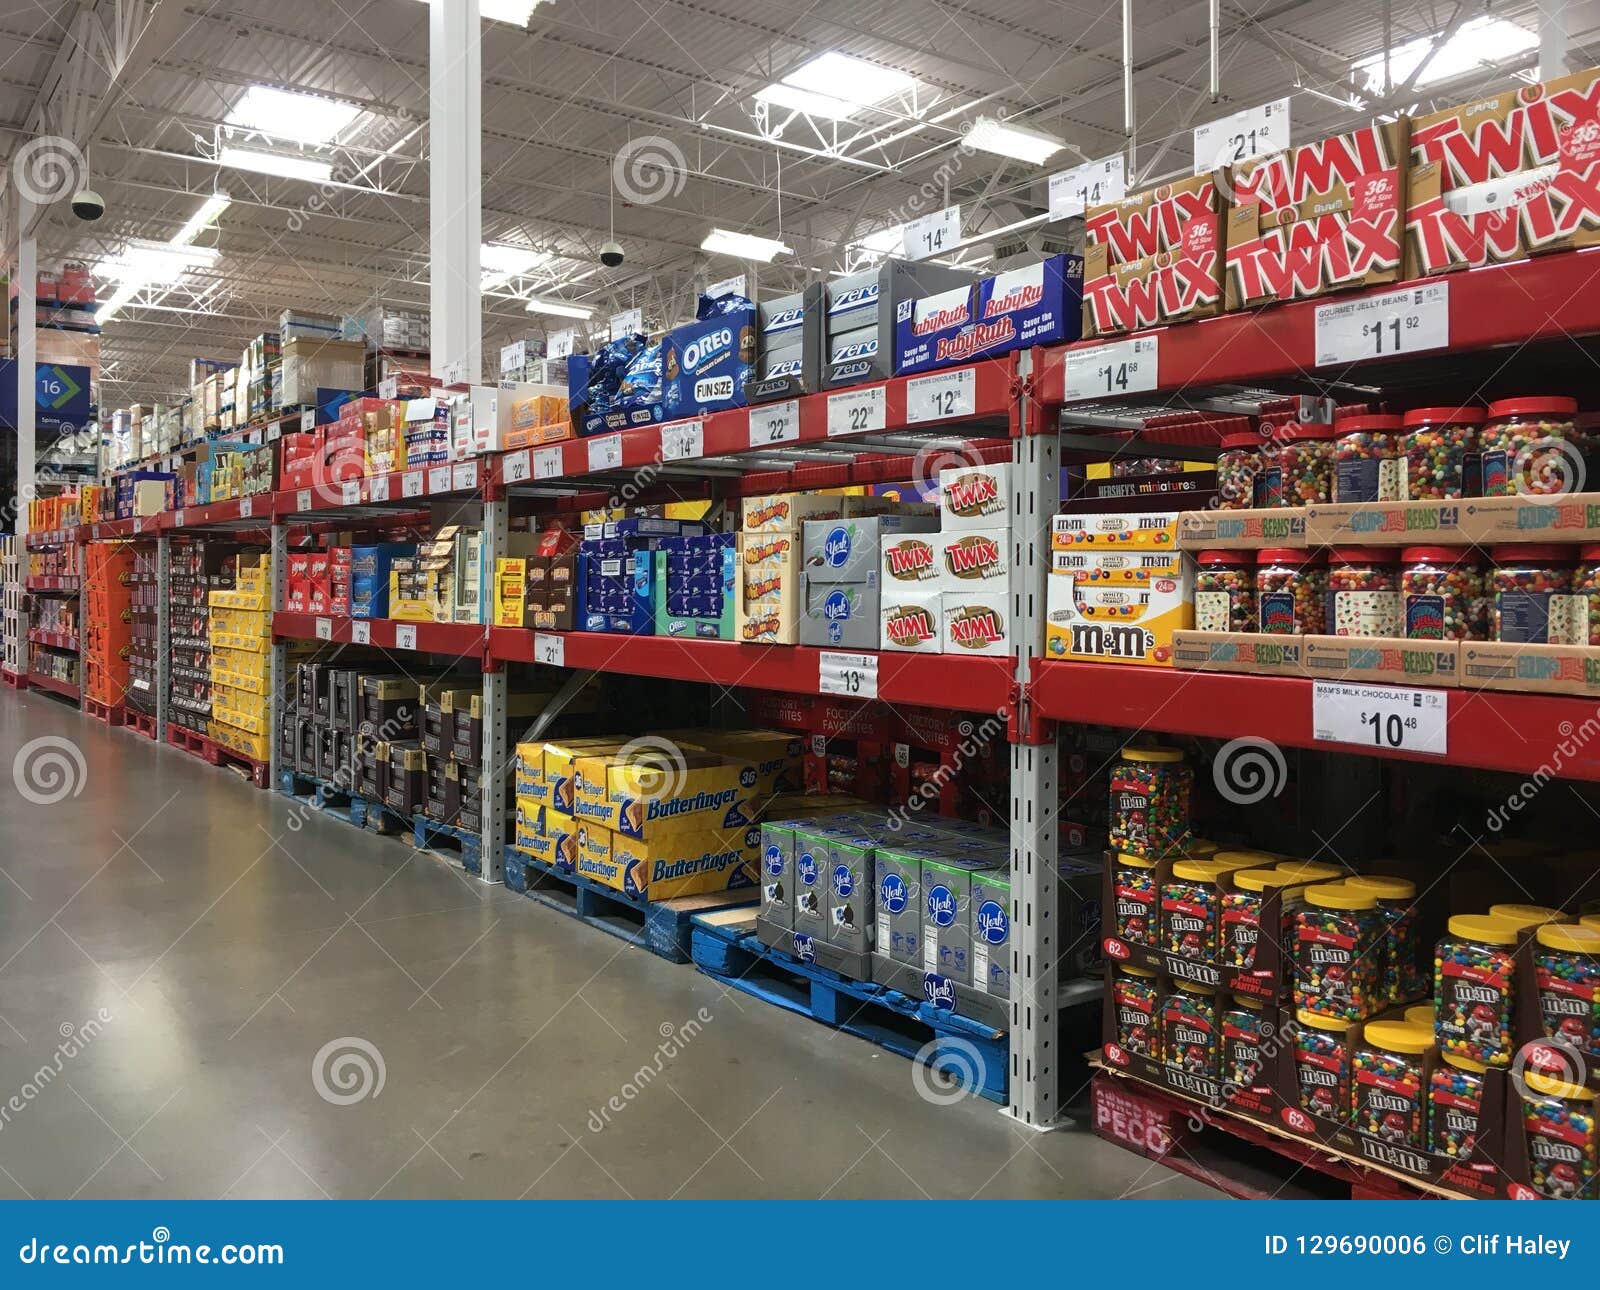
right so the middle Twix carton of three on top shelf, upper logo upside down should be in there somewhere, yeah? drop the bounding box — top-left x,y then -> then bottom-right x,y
1227,120 -> 1408,309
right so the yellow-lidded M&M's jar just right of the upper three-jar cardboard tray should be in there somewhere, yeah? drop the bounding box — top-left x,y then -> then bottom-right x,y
1294,883 -> 1381,1021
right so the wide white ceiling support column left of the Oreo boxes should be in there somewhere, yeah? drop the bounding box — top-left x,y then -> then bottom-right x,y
427,0 -> 483,383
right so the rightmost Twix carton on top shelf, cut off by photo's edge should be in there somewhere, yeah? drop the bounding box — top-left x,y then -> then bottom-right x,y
1406,69 -> 1600,277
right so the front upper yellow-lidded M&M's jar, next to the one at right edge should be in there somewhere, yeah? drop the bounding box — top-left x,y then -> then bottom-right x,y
1434,914 -> 1522,1066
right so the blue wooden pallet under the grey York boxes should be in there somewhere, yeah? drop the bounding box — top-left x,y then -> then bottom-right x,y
690,914 -> 1010,1106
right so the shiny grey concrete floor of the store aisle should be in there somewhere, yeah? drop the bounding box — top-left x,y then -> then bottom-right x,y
0,693 -> 1214,1197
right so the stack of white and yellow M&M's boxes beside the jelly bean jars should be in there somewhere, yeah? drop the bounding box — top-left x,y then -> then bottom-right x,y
1045,511 -> 1194,667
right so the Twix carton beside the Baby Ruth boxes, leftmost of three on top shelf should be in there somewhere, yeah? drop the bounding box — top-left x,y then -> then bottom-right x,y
1083,174 -> 1222,338
